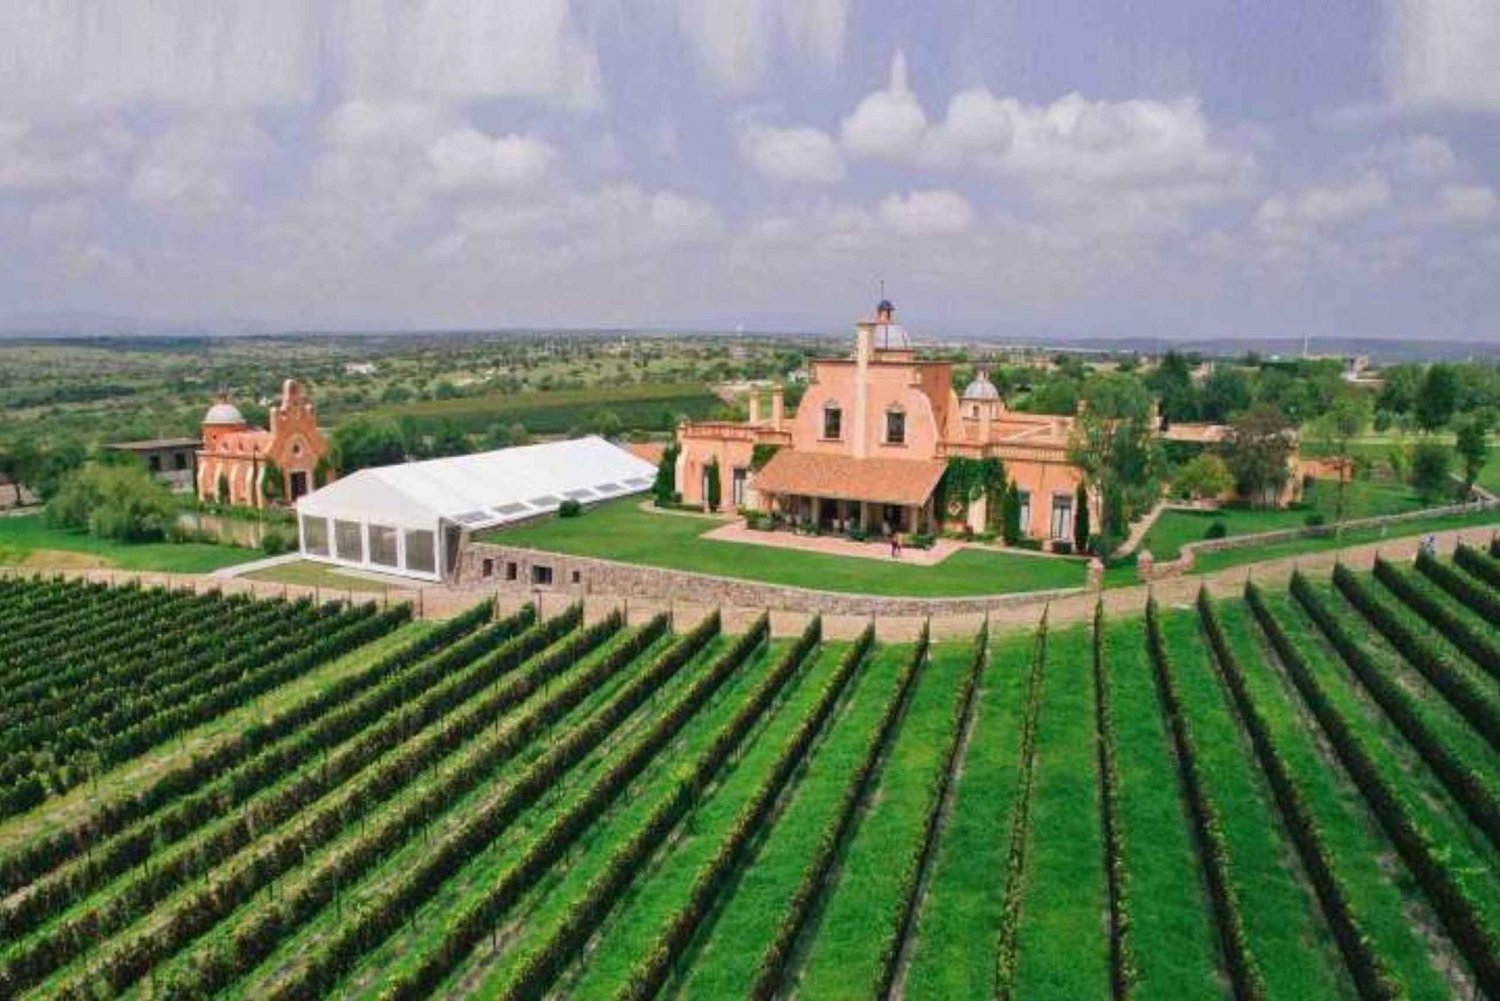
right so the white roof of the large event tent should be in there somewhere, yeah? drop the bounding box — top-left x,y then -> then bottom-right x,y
297,437 -> 656,528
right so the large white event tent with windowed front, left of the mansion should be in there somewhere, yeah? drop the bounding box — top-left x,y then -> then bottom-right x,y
297,437 -> 656,581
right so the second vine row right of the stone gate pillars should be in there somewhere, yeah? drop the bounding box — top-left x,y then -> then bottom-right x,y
1199,588 -> 1406,1001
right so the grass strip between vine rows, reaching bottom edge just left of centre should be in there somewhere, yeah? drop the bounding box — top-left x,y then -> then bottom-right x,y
678,647 -> 911,998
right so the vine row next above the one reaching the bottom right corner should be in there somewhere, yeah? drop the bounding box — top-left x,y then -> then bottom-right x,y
1292,573 -> 1500,846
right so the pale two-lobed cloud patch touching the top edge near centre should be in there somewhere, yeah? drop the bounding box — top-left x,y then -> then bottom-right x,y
678,0 -> 849,95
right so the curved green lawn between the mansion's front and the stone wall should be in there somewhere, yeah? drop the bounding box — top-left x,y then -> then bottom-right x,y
480,498 -> 1085,597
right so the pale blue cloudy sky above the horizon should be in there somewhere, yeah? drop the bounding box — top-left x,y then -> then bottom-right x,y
0,0 -> 1500,341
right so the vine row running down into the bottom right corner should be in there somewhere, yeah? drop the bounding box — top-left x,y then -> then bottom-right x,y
1245,573 -> 1500,996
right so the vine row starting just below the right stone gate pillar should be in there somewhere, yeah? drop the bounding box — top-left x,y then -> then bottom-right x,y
1146,597 -> 1266,998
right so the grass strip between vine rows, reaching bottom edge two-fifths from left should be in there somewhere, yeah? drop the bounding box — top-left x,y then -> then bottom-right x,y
566,644 -> 848,998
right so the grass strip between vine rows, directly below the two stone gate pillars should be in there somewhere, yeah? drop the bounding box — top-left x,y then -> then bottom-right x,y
1104,618 -> 1227,999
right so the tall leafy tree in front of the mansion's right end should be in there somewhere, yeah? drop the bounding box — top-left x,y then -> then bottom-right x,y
1068,372 -> 1161,552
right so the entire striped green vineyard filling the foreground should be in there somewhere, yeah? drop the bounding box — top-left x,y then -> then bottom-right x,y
0,549 -> 1500,999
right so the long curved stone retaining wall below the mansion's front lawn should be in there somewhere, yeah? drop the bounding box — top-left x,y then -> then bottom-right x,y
456,542 -> 1083,618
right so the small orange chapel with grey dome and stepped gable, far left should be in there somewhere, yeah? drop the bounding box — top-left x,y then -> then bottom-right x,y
197,378 -> 332,507
